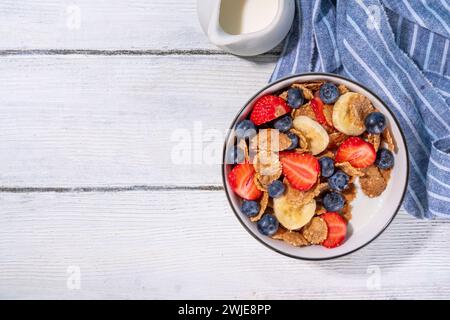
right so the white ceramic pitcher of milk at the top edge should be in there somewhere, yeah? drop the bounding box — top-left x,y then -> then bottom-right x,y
197,0 -> 295,56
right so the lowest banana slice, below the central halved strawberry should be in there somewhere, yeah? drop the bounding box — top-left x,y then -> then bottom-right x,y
273,196 -> 316,230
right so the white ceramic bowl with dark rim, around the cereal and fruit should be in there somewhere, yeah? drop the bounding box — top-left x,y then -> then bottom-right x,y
222,73 -> 409,260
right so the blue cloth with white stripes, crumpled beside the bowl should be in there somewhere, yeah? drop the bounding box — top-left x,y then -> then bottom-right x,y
271,0 -> 450,218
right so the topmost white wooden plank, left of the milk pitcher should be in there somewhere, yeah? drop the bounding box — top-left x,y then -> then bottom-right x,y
0,0 -> 280,51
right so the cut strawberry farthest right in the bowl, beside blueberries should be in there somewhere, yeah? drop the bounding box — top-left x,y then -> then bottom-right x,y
335,137 -> 377,168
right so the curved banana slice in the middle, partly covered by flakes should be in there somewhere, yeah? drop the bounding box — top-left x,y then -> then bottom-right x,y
293,116 -> 330,155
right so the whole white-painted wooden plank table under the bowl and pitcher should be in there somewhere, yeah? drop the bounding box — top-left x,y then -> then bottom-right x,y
0,0 -> 450,299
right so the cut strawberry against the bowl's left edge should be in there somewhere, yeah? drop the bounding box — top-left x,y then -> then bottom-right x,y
228,163 -> 262,200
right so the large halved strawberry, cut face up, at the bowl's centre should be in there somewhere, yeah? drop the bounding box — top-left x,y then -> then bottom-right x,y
280,152 -> 320,191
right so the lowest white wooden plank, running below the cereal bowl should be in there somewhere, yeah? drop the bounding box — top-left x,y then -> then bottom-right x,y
0,190 -> 450,299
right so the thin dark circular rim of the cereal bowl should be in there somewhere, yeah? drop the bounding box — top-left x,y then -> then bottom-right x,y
221,72 -> 410,261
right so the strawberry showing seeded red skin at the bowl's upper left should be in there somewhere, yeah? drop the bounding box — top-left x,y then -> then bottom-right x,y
250,95 -> 291,126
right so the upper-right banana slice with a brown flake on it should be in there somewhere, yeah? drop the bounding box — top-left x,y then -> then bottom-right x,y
333,92 -> 374,136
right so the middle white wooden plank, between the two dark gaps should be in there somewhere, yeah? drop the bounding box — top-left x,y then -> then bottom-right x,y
0,55 -> 276,187
